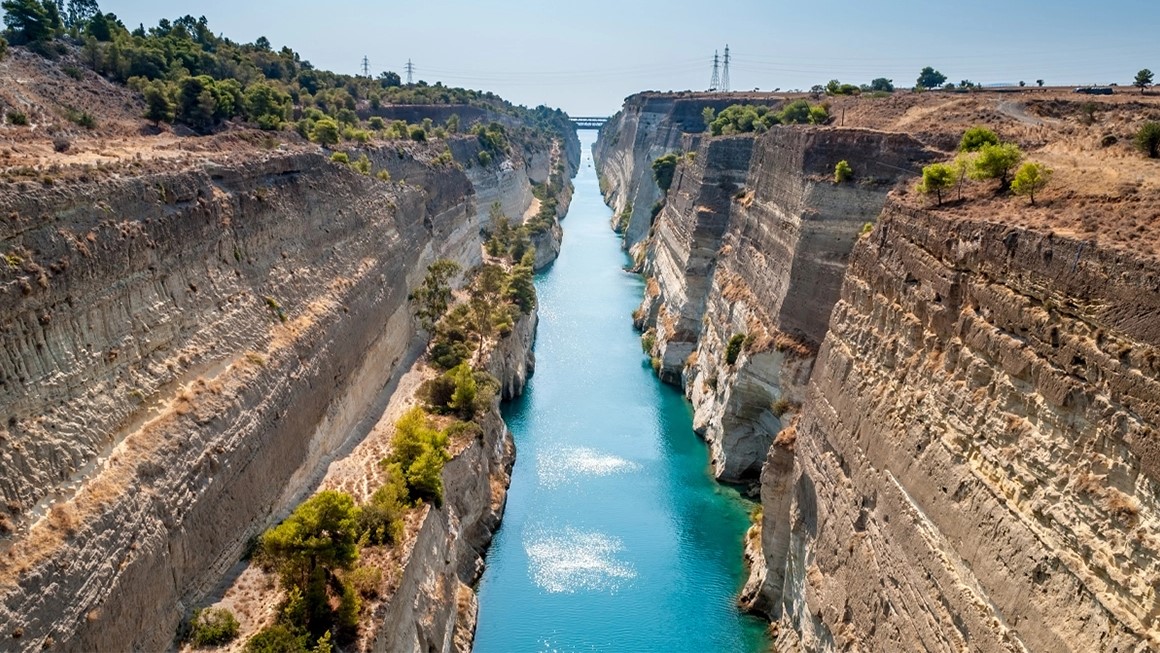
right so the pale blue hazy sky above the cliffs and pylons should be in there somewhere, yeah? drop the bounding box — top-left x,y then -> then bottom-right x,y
101,0 -> 1160,115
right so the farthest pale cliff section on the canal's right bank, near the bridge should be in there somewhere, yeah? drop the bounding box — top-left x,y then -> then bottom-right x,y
594,93 -> 737,249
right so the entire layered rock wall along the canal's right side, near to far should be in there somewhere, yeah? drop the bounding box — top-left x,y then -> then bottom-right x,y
596,93 -> 1160,652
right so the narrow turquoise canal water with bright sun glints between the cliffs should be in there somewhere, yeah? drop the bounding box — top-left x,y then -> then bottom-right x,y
474,132 -> 764,653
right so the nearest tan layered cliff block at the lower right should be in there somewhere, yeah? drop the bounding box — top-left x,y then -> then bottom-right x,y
762,205 -> 1160,651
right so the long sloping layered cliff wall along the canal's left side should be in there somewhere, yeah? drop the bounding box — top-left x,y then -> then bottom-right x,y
0,131 -> 563,651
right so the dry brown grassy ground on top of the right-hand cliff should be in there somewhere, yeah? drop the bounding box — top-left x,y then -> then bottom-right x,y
834,89 -> 1160,256
